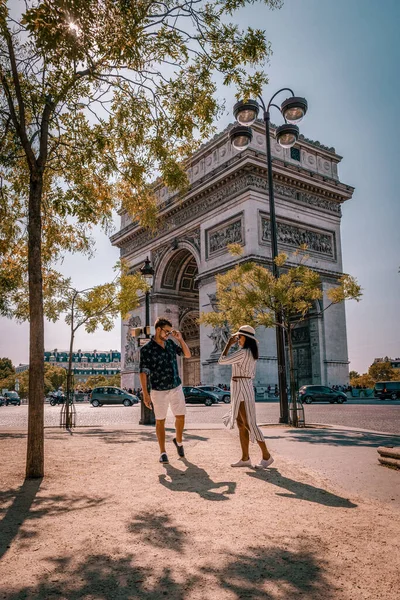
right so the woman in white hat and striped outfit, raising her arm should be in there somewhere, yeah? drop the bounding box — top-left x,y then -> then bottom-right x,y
218,325 -> 274,469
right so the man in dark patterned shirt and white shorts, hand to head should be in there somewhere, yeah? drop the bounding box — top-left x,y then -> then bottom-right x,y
139,317 -> 190,464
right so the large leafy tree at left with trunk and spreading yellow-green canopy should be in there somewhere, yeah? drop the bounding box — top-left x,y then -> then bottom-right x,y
0,0 -> 281,477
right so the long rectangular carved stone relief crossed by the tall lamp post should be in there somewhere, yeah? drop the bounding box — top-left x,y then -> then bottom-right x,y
261,216 -> 335,259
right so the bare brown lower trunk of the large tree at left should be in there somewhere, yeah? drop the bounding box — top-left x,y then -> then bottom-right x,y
26,173 -> 44,479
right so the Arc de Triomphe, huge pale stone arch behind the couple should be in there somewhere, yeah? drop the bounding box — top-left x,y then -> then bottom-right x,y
111,122 -> 354,387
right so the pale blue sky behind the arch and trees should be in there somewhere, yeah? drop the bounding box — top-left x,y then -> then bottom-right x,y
0,0 -> 400,372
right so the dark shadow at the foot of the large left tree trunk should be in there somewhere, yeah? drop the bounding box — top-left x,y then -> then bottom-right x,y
0,478 -> 105,558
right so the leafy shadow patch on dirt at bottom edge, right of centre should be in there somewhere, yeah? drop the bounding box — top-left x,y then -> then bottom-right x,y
202,546 -> 336,600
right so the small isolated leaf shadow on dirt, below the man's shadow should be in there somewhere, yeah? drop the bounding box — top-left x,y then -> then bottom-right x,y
128,511 -> 185,552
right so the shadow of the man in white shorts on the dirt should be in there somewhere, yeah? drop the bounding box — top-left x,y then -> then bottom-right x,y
159,458 -> 236,501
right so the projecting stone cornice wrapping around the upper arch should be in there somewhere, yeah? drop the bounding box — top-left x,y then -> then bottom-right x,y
111,150 -> 353,255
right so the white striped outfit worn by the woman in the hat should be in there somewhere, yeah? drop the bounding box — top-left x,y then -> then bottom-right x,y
218,348 -> 264,442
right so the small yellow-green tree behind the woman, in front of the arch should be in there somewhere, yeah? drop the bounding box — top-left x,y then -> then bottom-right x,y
200,244 -> 361,427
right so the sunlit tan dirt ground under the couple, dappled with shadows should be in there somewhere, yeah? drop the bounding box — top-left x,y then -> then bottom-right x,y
0,428 -> 400,600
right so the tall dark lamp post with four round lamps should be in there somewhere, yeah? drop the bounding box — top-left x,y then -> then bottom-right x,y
230,88 -> 308,423
